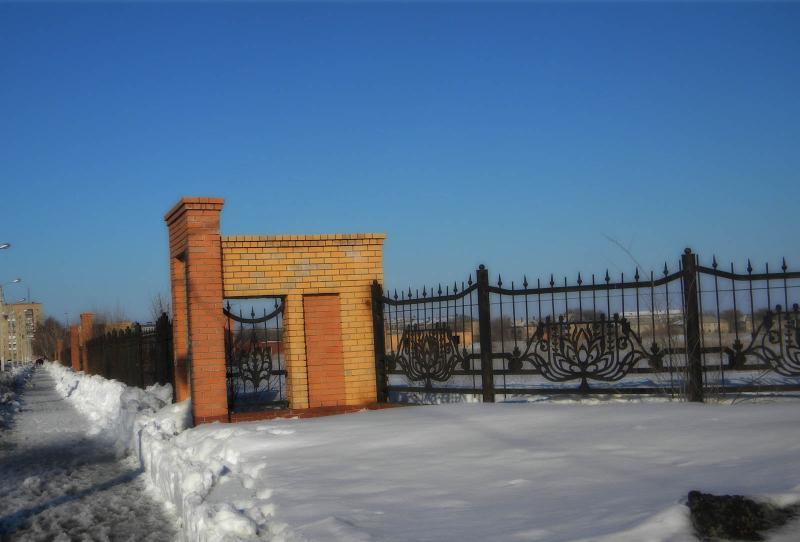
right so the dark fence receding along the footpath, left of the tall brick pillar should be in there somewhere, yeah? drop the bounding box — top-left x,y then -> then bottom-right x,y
83,314 -> 175,394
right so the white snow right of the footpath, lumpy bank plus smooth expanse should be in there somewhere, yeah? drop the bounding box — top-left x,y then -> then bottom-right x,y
7,366 -> 800,542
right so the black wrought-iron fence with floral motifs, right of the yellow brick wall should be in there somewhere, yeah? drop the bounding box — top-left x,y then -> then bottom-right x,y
373,249 -> 800,402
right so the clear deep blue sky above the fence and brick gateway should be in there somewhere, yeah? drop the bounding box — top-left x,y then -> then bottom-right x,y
0,3 -> 800,326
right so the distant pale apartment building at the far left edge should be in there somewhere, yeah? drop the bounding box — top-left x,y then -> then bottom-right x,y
0,298 -> 42,361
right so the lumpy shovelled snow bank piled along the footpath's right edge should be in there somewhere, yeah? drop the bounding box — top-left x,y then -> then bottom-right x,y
45,363 -> 286,542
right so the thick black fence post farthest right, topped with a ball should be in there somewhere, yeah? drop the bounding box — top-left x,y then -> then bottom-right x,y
681,248 -> 703,403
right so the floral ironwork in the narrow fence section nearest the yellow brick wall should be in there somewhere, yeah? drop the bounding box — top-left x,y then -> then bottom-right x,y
386,323 -> 469,389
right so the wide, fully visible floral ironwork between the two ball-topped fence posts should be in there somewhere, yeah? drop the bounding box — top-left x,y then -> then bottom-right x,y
509,314 -> 665,391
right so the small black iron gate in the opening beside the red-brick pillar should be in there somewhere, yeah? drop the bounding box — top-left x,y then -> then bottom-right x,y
223,298 -> 288,412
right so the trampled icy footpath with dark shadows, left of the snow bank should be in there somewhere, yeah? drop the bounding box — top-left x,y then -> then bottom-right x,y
0,369 -> 177,541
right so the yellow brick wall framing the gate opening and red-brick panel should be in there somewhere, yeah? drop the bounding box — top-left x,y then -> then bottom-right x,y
222,233 -> 386,408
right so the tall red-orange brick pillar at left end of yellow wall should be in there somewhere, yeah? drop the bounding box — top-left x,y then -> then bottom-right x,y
164,198 -> 228,423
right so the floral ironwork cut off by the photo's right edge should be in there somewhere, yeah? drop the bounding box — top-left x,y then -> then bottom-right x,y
726,303 -> 800,376
